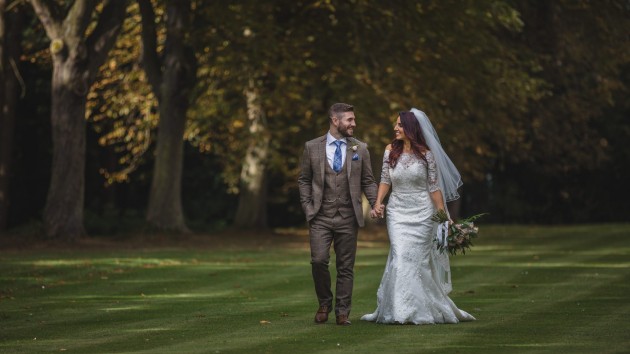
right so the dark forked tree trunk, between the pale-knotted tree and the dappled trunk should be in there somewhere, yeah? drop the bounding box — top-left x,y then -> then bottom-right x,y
145,0 -> 197,232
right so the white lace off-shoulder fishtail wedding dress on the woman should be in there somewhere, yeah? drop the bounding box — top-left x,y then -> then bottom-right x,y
361,151 -> 475,324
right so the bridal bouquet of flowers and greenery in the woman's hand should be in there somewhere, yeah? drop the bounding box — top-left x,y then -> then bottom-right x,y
431,210 -> 487,256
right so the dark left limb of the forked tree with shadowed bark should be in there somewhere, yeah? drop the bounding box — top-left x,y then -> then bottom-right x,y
138,0 -> 162,101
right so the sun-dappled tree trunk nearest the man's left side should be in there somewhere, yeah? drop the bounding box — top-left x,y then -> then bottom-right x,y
234,79 -> 269,229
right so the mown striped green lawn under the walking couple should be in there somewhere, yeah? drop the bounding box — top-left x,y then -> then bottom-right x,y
0,225 -> 630,353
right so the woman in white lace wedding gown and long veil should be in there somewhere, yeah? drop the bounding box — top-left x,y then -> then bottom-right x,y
361,109 -> 475,324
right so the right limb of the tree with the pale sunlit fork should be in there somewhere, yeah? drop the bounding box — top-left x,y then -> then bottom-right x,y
86,0 -> 127,83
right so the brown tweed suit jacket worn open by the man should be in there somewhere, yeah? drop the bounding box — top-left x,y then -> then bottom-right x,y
298,135 -> 378,226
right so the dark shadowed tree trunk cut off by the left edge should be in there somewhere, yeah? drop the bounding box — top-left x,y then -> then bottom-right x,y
0,0 -> 23,232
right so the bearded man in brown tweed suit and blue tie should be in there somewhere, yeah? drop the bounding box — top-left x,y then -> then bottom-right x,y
298,103 -> 377,325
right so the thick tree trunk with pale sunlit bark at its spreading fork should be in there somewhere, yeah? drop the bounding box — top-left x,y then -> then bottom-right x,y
29,0 -> 127,240
